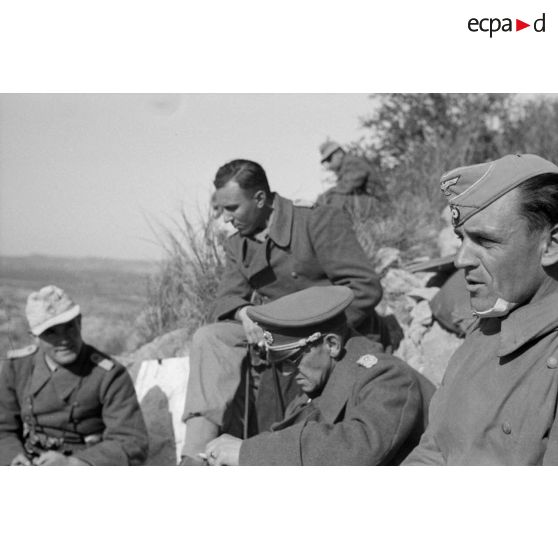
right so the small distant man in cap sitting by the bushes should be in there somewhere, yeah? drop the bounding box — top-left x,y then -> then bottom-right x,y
317,140 -> 388,220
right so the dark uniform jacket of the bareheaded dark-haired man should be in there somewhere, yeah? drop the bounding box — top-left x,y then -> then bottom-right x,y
214,194 -> 382,332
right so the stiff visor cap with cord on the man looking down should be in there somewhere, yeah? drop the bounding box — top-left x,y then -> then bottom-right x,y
246,286 -> 354,362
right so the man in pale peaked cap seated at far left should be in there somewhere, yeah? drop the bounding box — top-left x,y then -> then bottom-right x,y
0,285 -> 147,465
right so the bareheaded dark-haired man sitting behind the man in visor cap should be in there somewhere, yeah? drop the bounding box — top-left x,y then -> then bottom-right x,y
182,159 -> 389,464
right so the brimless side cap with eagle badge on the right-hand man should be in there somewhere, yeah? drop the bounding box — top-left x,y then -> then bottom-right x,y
440,154 -> 558,227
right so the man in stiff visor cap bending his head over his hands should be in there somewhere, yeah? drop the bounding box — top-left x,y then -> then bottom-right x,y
205,286 -> 434,465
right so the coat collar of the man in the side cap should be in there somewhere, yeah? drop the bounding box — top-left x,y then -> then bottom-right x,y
498,288 -> 558,357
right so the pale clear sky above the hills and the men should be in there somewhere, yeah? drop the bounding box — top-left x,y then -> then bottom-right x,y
0,93 -> 373,259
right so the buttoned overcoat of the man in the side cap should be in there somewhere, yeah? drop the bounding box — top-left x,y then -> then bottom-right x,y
404,292 -> 558,465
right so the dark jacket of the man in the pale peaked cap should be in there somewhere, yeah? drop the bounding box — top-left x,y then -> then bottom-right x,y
0,345 -> 148,465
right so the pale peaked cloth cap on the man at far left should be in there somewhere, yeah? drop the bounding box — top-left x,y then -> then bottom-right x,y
25,285 -> 80,335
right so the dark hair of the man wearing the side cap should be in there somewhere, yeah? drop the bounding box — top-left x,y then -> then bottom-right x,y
518,172 -> 558,232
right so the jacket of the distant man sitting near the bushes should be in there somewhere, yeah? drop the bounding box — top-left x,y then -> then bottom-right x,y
318,154 -> 388,213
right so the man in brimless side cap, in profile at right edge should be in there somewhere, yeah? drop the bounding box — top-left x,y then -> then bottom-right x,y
405,155 -> 558,465
